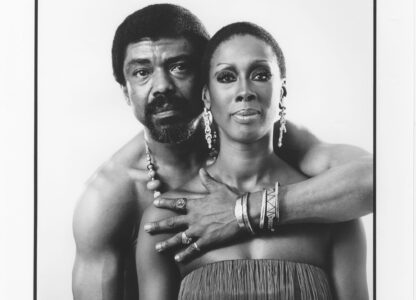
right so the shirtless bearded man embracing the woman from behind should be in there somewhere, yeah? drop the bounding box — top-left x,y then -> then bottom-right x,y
73,4 -> 372,299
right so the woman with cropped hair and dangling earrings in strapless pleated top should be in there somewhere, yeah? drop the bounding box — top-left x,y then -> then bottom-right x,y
136,23 -> 368,300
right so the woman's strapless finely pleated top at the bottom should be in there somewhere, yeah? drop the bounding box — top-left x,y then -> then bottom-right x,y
178,259 -> 332,300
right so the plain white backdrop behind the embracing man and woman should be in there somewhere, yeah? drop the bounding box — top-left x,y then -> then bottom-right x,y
37,0 -> 373,300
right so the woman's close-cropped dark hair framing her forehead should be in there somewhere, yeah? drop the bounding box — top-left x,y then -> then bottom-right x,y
202,22 -> 286,83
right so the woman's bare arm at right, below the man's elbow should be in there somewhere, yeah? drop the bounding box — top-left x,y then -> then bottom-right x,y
331,220 -> 368,300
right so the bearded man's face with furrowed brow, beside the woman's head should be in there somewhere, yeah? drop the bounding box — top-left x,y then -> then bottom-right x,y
123,37 -> 202,143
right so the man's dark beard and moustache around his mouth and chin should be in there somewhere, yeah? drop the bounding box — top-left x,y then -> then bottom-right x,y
144,95 -> 202,144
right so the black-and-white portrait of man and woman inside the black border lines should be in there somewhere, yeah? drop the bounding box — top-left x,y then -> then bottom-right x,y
1,0 -> 413,300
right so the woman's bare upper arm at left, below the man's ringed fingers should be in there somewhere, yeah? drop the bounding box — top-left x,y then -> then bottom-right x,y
136,206 -> 181,300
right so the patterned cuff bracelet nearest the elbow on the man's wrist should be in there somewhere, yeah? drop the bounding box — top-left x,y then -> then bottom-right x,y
260,182 -> 280,232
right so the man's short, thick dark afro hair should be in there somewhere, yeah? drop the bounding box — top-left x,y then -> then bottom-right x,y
111,4 -> 209,85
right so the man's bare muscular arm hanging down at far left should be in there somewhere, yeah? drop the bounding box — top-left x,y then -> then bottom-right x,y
72,167 -> 137,300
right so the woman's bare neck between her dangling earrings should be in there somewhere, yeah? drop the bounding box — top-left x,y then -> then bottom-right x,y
211,131 -> 278,191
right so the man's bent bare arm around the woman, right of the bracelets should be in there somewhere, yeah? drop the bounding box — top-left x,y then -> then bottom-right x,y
272,122 -> 373,224
